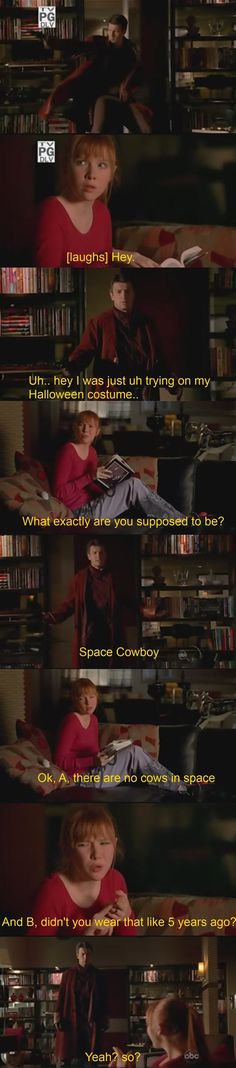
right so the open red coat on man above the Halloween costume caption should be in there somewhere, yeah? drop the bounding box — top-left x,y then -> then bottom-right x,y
70,308 -> 157,371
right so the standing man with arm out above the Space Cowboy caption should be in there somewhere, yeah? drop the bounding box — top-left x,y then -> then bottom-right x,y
46,538 -> 115,668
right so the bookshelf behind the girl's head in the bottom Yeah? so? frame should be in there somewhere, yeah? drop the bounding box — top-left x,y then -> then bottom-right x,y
129,963 -> 227,1054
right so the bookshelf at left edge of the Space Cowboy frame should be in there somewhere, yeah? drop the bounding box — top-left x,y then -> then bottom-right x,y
0,534 -> 46,668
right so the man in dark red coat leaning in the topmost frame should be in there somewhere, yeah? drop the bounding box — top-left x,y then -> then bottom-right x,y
38,14 -> 150,134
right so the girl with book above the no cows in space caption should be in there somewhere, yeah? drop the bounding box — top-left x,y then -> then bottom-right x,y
54,678 -> 187,800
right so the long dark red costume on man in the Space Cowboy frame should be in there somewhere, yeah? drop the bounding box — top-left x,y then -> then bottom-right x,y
53,566 -> 115,668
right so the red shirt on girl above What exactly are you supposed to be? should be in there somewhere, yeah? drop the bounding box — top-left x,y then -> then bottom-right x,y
53,441 -> 99,512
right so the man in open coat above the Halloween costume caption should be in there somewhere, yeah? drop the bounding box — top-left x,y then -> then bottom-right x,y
68,271 -> 157,384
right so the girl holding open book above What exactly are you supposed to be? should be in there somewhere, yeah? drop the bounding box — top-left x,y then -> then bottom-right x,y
53,410 -> 182,522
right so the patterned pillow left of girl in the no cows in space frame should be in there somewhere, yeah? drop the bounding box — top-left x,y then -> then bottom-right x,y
0,738 -> 77,797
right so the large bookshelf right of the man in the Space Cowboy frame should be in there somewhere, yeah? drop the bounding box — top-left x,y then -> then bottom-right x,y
140,534 -> 236,668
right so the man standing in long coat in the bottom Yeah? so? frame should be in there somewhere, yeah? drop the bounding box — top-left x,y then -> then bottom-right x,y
56,940 -> 104,1068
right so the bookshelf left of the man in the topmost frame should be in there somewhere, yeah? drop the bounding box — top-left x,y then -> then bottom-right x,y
0,0 -> 83,137
